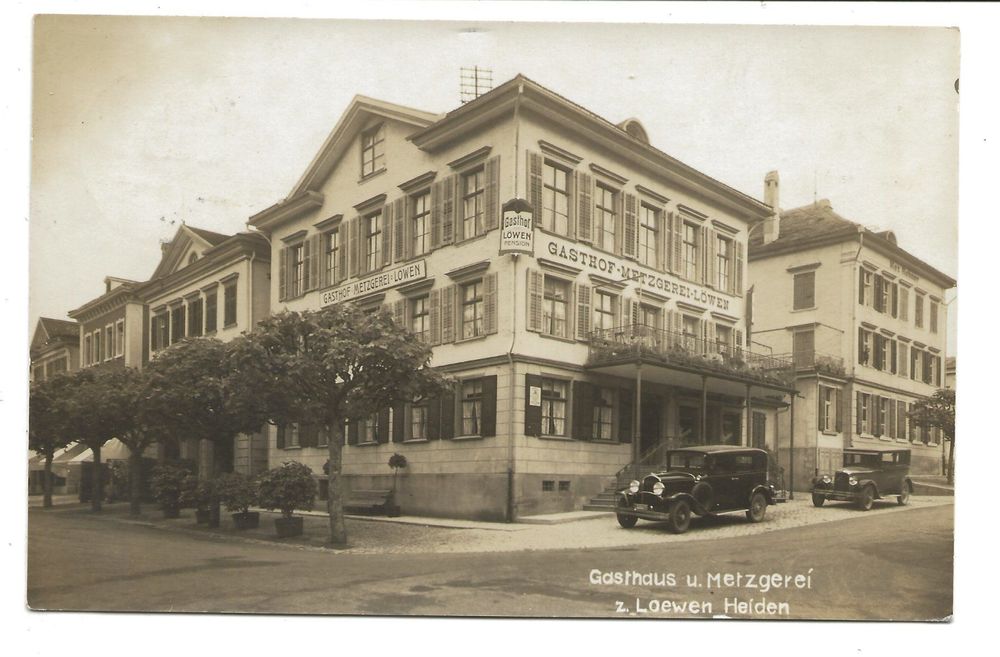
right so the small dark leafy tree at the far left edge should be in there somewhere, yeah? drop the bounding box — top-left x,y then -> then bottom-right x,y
28,375 -> 72,508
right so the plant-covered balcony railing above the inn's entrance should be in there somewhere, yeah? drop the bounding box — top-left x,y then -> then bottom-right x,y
588,324 -> 794,387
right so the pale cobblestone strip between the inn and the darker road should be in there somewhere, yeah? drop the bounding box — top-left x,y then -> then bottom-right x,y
92,495 -> 954,554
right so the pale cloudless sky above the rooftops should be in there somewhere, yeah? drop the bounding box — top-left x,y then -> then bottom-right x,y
28,16 -> 959,354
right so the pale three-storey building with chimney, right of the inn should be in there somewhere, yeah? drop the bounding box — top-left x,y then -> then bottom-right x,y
749,177 -> 955,489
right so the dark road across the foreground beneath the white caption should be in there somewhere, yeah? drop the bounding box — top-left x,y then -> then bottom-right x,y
28,505 -> 953,620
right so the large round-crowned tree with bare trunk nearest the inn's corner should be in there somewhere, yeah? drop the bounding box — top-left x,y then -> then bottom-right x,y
229,303 -> 444,545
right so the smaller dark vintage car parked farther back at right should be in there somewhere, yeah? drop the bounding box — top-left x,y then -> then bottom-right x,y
812,446 -> 913,511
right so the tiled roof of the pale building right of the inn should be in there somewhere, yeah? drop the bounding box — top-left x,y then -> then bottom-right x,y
747,199 -> 956,289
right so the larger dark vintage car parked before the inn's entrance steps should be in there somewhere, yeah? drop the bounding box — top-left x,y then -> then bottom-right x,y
615,445 -> 785,534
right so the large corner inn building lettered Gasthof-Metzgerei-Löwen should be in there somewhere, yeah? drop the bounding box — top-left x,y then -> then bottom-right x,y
249,76 -> 791,519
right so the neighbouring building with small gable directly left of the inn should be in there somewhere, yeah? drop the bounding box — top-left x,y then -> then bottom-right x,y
139,225 -> 271,476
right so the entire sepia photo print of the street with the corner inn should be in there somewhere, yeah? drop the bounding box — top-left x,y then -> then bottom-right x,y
11,2 -> 988,647
